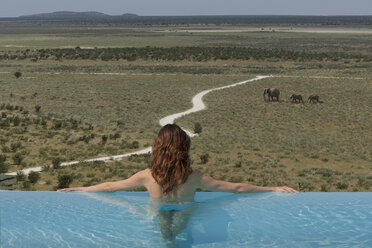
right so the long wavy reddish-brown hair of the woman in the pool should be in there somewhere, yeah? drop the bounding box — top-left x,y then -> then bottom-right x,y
151,124 -> 192,194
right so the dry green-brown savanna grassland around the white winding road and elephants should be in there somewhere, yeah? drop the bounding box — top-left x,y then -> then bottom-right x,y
0,21 -> 372,191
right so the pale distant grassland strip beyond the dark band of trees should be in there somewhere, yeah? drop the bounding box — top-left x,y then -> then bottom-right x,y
0,25 -> 372,55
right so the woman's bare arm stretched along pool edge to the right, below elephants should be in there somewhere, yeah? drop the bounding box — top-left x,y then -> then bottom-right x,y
197,172 -> 298,193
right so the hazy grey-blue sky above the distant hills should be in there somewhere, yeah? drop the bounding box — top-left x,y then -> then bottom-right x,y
0,0 -> 372,17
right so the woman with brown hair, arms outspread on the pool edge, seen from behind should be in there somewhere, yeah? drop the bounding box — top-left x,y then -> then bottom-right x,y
59,124 -> 297,198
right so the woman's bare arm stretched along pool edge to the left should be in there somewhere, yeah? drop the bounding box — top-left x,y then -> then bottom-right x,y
58,170 -> 146,192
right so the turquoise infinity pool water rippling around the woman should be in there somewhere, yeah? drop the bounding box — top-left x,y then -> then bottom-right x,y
0,191 -> 372,248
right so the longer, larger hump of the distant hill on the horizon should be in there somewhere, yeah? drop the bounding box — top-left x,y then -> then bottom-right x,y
19,11 -> 110,19
